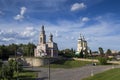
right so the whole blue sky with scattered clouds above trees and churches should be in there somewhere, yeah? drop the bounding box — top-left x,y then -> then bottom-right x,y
0,0 -> 120,51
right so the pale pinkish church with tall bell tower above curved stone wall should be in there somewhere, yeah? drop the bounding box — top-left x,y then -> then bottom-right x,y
34,26 -> 58,57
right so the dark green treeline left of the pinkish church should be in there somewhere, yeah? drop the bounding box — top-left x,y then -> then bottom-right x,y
0,43 -> 36,59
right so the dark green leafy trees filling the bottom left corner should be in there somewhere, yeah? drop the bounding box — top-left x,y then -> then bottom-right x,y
0,59 -> 23,80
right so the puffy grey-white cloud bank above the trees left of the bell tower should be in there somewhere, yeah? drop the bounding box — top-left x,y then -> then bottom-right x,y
0,27 -> 37,44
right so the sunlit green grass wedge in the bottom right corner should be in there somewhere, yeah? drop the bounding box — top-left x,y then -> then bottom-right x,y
82,68 -> 120,80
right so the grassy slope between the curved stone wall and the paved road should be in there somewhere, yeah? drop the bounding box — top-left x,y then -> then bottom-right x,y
43,60 -> 91,68
